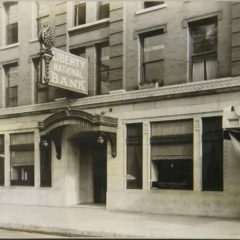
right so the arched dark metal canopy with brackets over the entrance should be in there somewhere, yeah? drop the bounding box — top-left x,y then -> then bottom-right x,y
38,109 -> 118,159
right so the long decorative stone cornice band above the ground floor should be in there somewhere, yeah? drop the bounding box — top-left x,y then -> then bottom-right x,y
0,77 -> 240,118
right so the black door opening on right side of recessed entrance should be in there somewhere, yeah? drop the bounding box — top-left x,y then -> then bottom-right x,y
92,143 -> 107,204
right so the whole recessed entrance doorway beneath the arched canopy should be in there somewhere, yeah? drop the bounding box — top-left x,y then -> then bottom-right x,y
79,134 -> 107,204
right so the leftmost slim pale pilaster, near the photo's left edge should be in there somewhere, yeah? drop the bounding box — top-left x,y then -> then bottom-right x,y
4,133 -> 11,187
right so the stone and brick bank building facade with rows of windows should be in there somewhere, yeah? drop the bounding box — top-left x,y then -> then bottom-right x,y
0,0 -> 240,217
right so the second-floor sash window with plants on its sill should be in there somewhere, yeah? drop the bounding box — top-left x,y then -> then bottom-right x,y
139,29 -> 164,86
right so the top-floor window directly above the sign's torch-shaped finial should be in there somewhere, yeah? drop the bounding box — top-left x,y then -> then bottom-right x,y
36,1 -> 49,34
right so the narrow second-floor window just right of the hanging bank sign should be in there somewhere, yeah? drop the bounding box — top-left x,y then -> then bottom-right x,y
96,42 -> 109,94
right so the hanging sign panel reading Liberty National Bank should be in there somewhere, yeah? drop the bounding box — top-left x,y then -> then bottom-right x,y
48,48 -> 88,94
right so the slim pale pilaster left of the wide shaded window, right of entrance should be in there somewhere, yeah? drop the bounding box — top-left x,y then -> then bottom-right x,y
143,121 -> 151,190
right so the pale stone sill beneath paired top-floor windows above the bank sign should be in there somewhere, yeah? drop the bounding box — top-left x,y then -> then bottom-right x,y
68,18 -> 109,35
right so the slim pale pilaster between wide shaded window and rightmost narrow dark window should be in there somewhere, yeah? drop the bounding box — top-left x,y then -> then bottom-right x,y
193,117 -> 202,191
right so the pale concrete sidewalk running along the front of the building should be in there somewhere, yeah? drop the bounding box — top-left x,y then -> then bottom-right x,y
0,204 -> 240,239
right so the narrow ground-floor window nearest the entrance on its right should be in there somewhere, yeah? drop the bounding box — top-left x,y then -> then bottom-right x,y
127,123 -> 142,189
